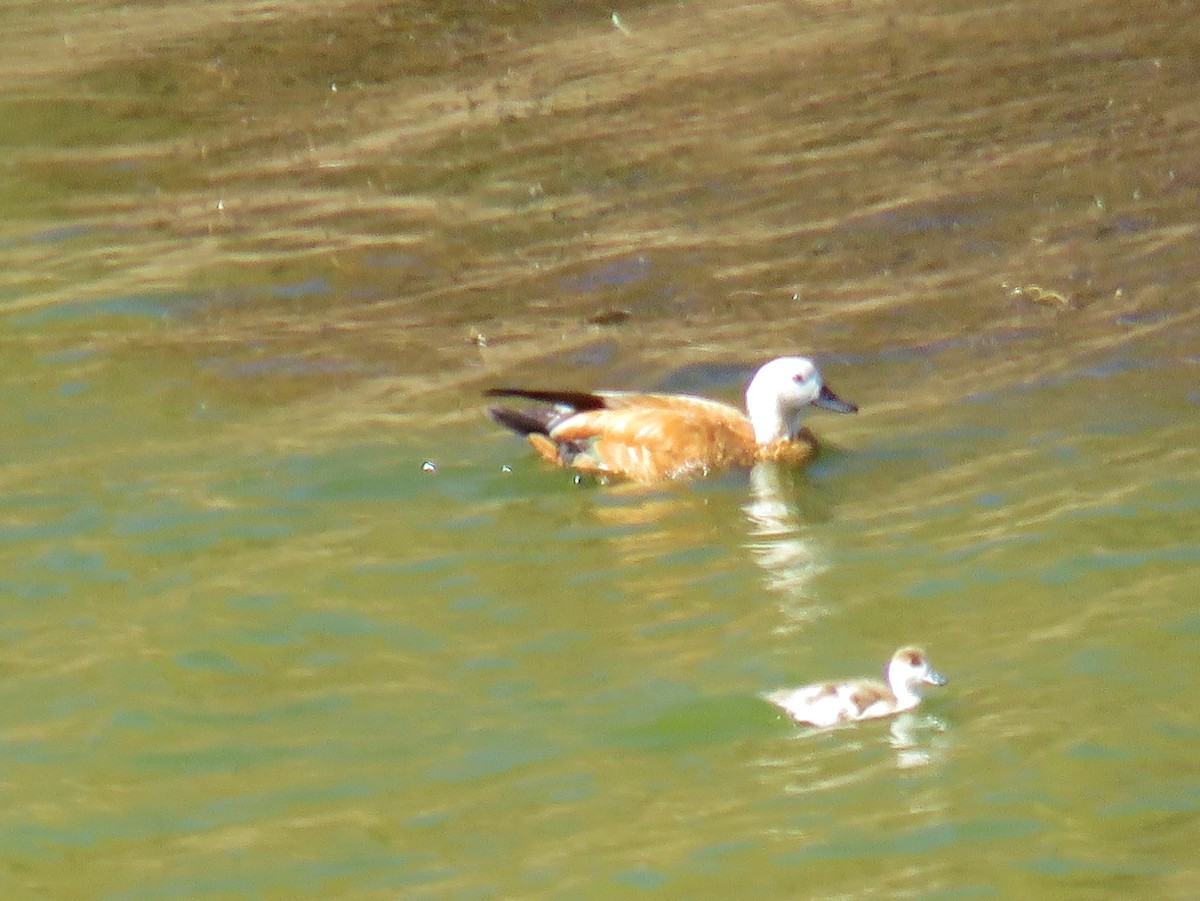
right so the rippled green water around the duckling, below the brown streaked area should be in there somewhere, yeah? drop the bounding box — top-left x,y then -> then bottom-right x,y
0,297 -> 1200,899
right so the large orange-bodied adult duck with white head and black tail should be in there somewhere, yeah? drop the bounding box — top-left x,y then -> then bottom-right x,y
486,356 -> 858,482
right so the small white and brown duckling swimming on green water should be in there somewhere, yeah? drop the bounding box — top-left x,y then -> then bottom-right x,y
763,647 -> 946,726
